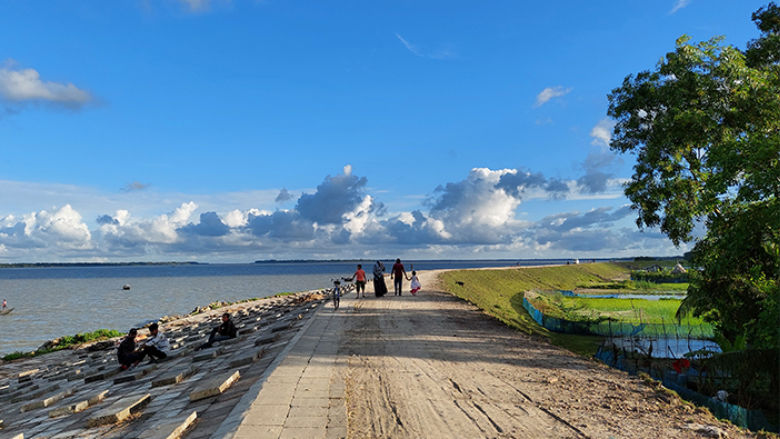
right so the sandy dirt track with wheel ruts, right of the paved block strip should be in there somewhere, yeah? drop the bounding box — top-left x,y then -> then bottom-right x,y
340,272 -> 749,438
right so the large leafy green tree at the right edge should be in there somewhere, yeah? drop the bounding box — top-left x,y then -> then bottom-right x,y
608,3 -> 780,349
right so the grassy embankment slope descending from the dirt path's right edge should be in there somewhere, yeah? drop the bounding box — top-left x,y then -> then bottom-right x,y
441,263 -> 628,356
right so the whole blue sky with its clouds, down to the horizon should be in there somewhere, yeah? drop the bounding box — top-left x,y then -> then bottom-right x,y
0,0 -> 764,263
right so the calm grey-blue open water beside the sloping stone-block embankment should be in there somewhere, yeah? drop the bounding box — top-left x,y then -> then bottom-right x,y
0,260 -> 565,355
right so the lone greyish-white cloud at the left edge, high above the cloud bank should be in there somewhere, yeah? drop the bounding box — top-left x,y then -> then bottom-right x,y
0,62 -> 93,109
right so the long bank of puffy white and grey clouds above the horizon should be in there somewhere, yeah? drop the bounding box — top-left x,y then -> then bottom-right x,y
0,165 -> 668,260
